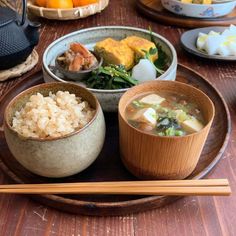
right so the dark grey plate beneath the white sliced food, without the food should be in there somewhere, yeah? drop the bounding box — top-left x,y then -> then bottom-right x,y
181,27 -> 236,61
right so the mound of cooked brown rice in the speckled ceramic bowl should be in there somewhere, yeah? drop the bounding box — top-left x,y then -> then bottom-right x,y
12,91 -> 95,138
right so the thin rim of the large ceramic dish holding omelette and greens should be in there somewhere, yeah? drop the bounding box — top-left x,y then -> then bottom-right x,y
42,25 -> 177,93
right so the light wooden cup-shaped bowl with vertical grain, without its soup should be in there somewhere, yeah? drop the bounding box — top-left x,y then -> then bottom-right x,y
119,81 -> 215,179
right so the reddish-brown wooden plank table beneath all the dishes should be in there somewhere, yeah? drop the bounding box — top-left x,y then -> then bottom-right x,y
0,0 -> 236,236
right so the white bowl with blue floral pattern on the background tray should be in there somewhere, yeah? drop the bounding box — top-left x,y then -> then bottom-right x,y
161,0 -> 236,18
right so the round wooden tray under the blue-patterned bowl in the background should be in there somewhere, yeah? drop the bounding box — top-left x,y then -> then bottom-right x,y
137,0 -> 236,28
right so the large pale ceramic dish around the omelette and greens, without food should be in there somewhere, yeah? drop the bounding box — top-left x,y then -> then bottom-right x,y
43,26 -> 177,112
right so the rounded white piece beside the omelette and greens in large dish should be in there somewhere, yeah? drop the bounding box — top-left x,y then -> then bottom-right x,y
132,59 -> 157,83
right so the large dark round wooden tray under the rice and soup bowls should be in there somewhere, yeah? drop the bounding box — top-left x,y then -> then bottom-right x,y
0,65 -> 230,215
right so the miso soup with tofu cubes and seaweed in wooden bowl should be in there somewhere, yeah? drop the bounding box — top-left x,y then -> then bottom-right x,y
125,92 -> 205,136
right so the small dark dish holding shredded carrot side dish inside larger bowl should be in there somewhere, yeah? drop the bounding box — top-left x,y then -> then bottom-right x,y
55,51 -> 103,81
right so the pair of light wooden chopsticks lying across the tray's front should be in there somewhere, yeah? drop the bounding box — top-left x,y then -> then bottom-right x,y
0,179 -> 231,196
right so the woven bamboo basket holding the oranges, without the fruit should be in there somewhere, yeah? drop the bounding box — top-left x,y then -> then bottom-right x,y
27,0 -> 109,20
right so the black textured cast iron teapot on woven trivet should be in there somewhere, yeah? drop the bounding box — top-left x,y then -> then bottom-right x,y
0,0 -> 40,70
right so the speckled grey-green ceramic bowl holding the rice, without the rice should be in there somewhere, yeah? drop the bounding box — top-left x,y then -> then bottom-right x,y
4,83 -> 105,178
